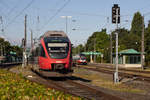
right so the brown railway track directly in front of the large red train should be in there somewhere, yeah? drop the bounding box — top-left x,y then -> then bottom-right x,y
29,69 -> 122,100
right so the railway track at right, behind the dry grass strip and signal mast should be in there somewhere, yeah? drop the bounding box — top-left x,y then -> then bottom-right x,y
79,66 -> 150,82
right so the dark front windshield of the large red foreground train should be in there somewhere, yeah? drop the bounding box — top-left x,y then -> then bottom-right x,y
45,37 -> 69,59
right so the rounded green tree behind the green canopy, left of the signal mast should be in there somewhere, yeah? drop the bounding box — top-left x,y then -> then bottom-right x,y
86,29 -> 109,62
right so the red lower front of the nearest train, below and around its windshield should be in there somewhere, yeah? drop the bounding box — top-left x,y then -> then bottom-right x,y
32,39 -> 73,77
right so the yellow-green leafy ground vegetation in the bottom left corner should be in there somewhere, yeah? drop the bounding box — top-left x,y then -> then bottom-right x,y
0,69 -> 82,100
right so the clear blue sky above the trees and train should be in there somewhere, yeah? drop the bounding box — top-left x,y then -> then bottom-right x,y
0,0 -> 150,45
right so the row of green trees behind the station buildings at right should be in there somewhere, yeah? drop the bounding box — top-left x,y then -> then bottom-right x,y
73,12 -> 150,65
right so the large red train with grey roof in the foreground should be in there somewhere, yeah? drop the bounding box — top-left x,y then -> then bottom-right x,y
29,31 -> 73,77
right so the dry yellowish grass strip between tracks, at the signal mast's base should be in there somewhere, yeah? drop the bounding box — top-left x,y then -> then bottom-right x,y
74,69 -> 145,93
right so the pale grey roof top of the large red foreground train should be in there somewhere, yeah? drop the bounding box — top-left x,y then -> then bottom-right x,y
40,31 -> 67,38
